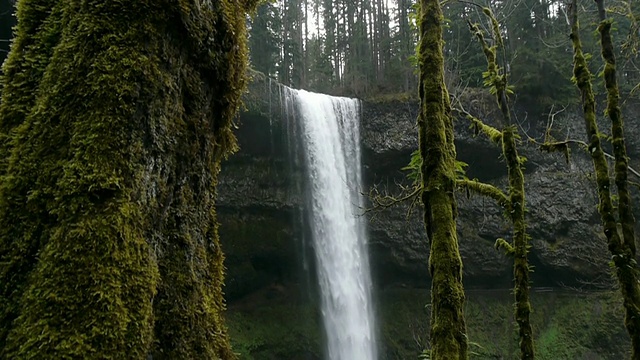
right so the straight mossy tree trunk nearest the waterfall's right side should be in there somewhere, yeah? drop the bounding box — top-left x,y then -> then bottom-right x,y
418,0 -> 468,360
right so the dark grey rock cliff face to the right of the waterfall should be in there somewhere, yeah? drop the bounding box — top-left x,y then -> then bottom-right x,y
362,96 -> 640,287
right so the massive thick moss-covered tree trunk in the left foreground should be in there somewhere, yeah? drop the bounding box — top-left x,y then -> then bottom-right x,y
0,0 -> 253,359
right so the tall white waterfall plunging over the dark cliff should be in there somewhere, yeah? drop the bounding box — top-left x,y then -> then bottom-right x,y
291,91 -> 377,360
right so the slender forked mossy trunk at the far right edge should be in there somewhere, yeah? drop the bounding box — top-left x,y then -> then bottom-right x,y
570,0 -> 640,359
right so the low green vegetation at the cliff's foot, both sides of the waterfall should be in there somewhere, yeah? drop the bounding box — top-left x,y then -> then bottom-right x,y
227,289 -> 629,360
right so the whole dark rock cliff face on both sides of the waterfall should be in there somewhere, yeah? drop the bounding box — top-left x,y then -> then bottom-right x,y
218,79 -> 640,298
